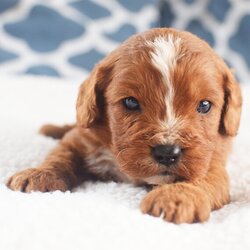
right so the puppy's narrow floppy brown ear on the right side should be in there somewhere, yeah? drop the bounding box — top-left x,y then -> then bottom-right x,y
219,70 -> 242,136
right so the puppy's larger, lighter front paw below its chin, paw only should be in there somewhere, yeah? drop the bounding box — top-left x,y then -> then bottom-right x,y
141,184 -> 211,224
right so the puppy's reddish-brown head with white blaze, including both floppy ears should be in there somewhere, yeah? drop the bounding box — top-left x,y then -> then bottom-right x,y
77,29 -> 241,184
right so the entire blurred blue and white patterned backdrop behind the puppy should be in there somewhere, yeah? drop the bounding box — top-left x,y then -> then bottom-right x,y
0,0 -> 250,83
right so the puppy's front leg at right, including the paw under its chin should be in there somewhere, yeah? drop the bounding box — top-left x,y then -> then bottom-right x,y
141,167 -> 229,224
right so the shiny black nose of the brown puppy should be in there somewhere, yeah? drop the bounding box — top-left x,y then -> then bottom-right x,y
152,144 -> 181,166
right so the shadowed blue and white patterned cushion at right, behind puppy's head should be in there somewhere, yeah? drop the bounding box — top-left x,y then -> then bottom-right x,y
160,0 -> 250,83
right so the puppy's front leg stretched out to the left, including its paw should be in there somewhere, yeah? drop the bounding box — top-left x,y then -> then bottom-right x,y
7,128 -> 88,192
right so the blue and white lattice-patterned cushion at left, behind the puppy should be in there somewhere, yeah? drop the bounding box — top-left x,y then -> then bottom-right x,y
0,0 -> 158,77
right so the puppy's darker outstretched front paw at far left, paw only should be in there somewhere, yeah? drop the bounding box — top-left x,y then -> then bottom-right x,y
7,168 -> 70,193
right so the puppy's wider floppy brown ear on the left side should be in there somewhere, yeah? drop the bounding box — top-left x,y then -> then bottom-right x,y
76,60 -> 113,128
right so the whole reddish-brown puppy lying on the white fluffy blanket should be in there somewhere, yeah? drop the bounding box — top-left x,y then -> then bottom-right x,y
7,28 -> 242,223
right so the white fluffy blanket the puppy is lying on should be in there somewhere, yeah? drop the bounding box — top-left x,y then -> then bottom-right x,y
0,76 -> 250,250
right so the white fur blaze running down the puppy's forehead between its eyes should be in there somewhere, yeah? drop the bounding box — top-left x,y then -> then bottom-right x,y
148,34 -> 181,127
